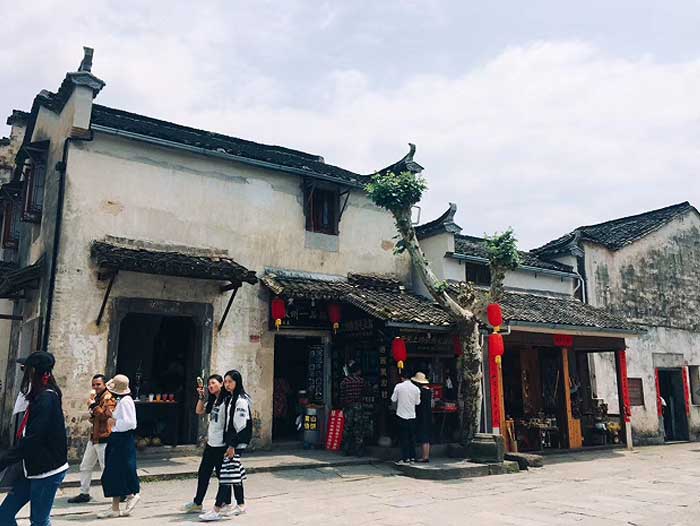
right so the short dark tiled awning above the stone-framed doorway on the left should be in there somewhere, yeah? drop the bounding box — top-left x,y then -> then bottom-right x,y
90,241 -> 258,285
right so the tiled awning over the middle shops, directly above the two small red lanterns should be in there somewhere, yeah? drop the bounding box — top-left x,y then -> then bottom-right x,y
260,270 -> 452,330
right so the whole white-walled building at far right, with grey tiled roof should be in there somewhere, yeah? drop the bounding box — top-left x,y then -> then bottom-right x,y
535,202 -> 700,443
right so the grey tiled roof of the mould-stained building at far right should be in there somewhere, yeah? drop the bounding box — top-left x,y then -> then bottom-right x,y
533,201 -> 697,254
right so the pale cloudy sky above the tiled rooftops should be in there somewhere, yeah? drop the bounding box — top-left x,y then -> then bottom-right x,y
0,0 -> 700,249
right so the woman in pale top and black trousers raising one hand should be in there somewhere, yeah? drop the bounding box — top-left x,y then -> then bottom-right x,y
182,374 -> 231,515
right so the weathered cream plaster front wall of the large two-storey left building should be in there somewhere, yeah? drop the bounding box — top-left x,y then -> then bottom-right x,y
50,133 -> 409,454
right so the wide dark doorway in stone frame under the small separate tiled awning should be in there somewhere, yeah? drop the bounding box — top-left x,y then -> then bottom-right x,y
117,313 -> 202,445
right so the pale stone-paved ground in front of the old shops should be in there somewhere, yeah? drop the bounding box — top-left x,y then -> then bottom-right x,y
12,443 -> 700,526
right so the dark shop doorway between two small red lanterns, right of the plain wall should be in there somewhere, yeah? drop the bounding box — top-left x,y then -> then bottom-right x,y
272,336 -> 326,442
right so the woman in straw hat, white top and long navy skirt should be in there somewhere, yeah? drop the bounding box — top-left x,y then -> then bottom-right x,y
98,374 -> 141,519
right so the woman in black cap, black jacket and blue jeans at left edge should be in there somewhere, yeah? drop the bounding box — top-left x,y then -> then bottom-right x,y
0,352 -> 68,526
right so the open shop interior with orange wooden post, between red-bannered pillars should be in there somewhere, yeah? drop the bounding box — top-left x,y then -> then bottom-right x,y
502,346 -> 623,451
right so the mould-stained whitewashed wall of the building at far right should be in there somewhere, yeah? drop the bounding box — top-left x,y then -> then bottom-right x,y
584,213 -> 700,442
